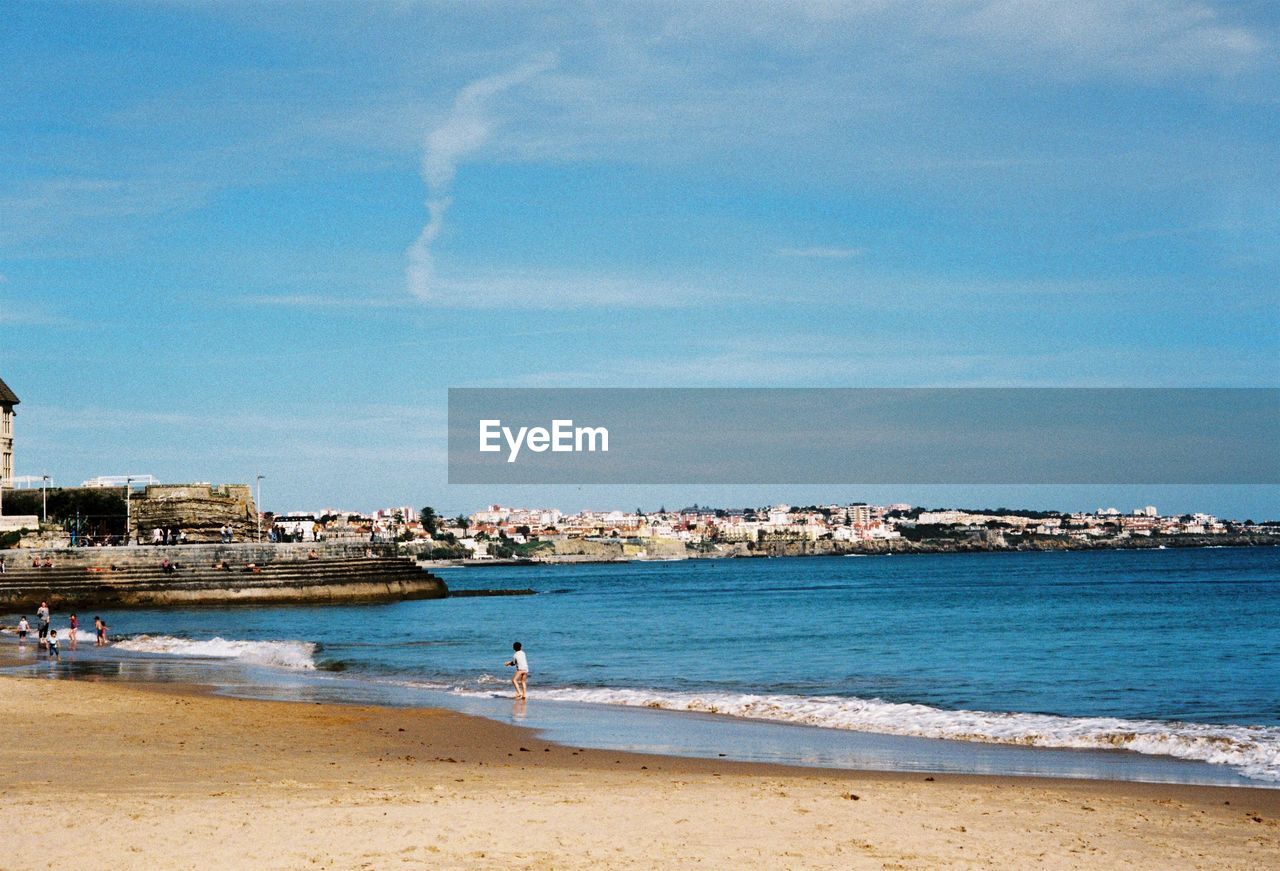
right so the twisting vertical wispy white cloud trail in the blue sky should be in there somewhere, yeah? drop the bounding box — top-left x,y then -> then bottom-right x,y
407,55 -> 556,301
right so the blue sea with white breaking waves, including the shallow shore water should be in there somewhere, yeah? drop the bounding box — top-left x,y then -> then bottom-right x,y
0,547 -> 1280,788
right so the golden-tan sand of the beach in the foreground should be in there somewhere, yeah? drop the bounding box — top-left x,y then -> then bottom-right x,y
0,678 -> 1280,868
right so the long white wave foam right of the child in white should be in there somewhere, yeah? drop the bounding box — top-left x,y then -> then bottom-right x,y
488,688 -> 1280,781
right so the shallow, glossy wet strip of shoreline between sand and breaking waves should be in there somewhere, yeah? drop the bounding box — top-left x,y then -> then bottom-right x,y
0,639 -> 1280,793
